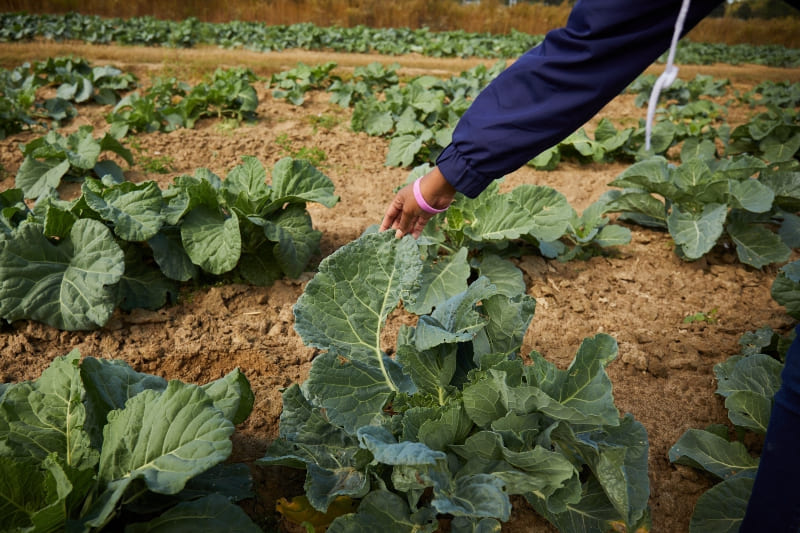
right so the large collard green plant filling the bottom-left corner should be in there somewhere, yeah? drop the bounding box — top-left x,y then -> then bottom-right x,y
0,351 -> 260,533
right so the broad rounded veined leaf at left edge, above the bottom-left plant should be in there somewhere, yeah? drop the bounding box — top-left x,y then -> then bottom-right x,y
0,219 -> 125,330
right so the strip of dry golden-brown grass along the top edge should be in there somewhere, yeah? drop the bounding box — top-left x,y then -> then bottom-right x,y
3,0 -> 800,48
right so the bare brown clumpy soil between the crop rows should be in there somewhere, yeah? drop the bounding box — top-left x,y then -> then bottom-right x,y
0,43 -> 798,533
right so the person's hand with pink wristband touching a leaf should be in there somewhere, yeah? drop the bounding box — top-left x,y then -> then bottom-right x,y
380,167 -> 456,239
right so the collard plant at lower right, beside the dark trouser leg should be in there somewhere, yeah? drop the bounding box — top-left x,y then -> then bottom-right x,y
669,328 -> 791,533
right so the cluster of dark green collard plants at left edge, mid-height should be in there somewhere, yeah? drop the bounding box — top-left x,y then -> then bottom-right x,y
0,156 -> 338,330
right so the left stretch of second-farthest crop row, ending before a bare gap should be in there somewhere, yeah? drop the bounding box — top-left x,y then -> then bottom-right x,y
0,56 -> 258,138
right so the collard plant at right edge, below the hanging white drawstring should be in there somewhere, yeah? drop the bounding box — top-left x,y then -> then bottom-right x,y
607,151 -> 800,268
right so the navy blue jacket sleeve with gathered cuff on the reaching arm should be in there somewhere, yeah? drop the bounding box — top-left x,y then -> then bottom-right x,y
436,0 -> 722,198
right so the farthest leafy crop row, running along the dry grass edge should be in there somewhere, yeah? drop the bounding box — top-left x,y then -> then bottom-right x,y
0,13 -> 800,67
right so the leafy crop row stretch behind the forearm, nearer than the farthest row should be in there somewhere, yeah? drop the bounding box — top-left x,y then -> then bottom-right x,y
270,62 -> 800,170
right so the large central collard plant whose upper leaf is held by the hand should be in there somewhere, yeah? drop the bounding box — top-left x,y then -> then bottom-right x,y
260,232 -> 649,532
